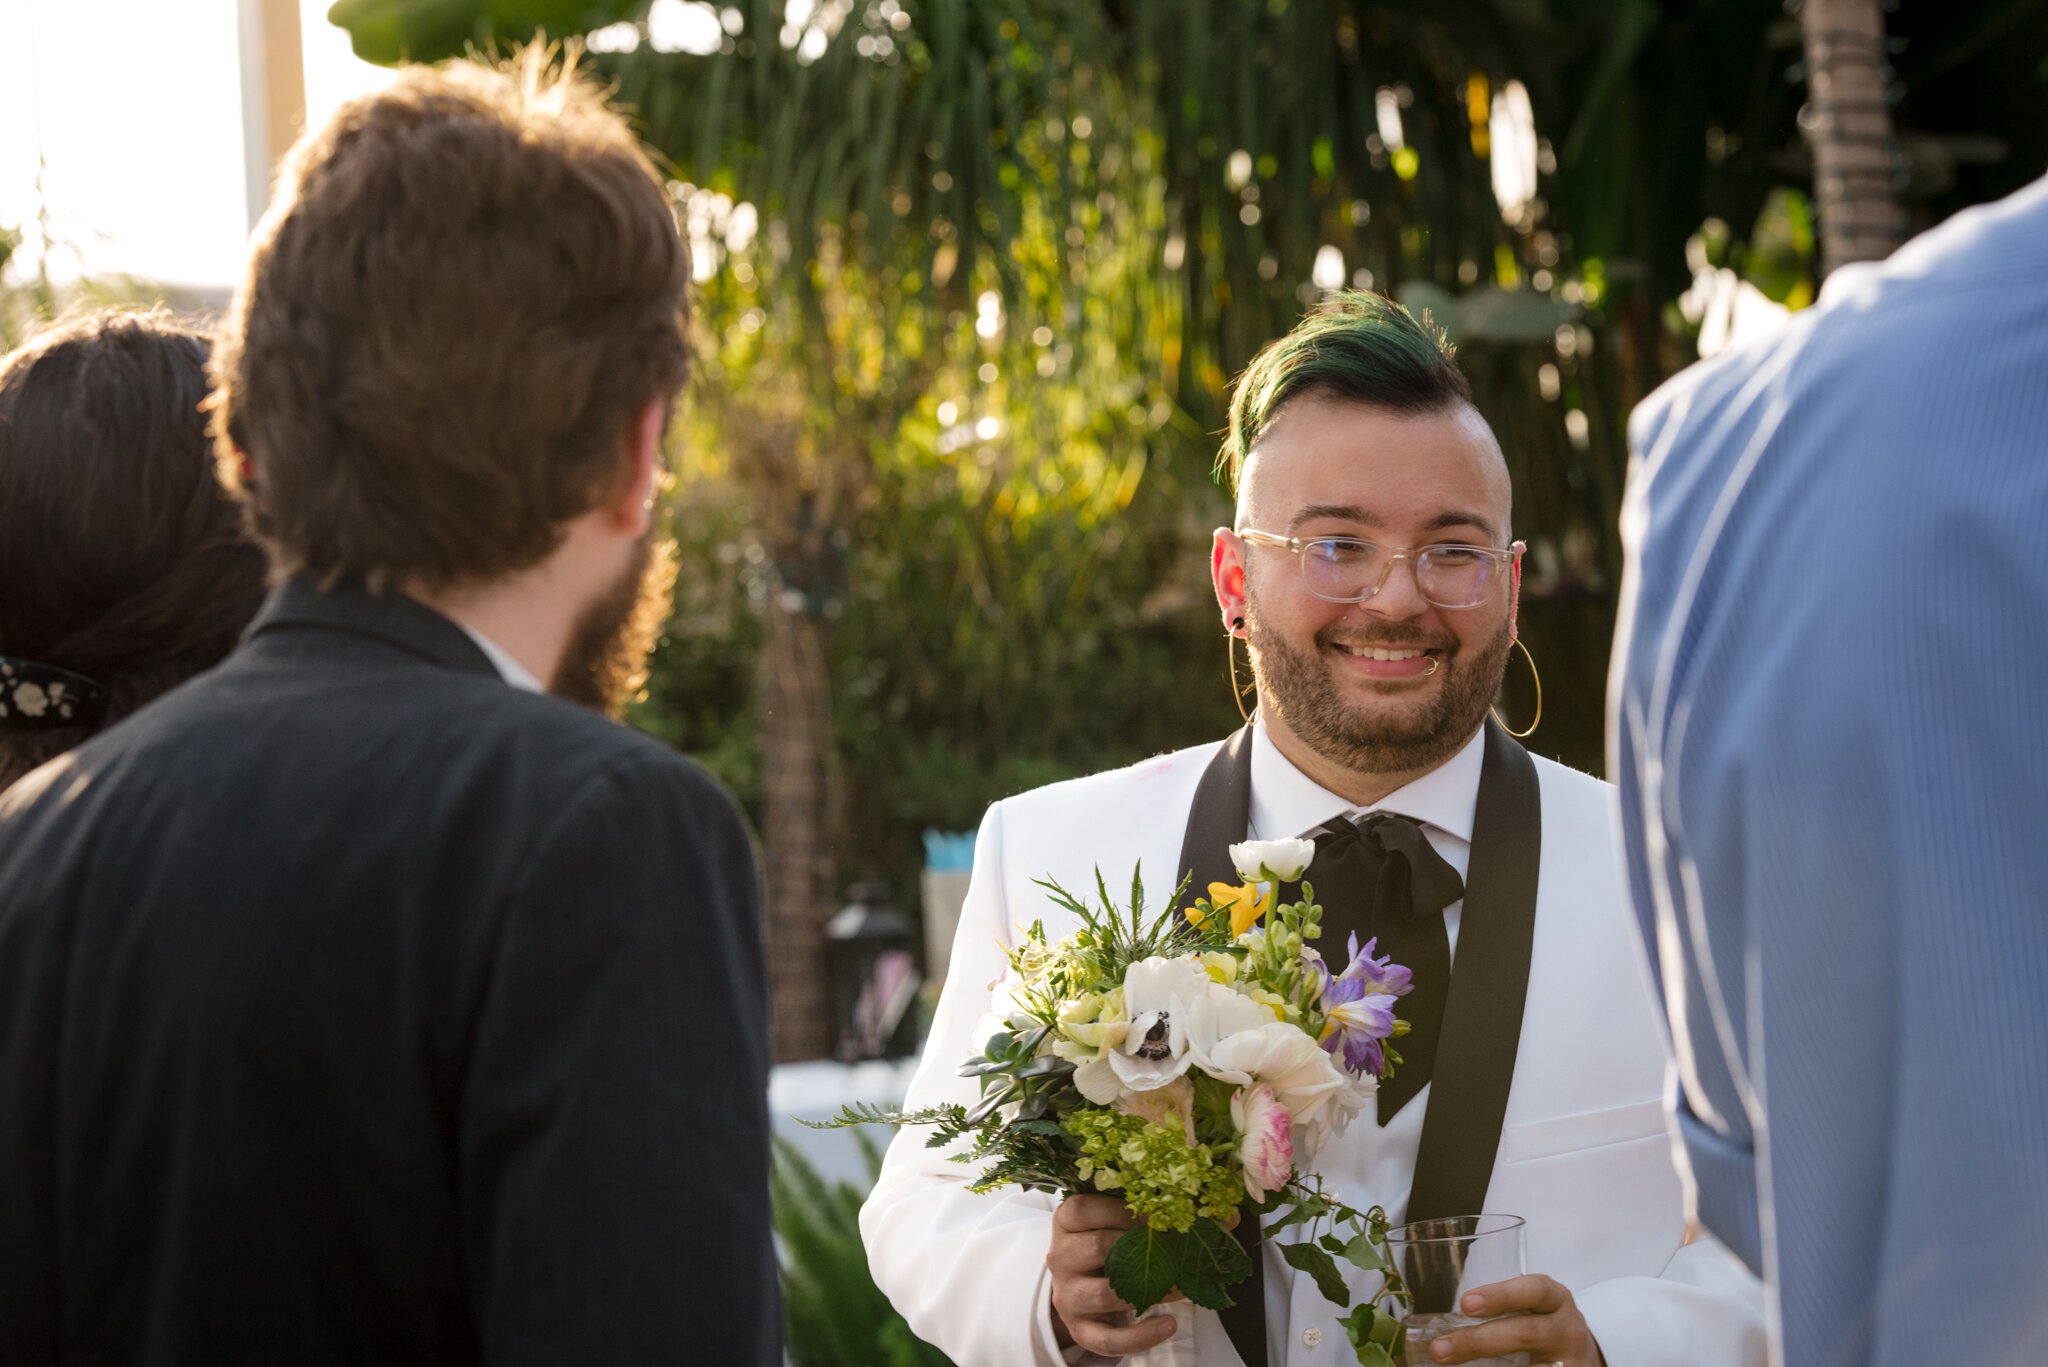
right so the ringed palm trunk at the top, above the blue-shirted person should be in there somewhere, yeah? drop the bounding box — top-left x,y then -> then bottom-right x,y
1800,0 -> 1901,275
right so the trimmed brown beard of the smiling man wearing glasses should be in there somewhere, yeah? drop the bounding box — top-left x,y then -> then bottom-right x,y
1245,594 -> 1513,773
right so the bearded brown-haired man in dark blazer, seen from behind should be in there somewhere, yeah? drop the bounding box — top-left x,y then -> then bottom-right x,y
0,49 -> 780,1367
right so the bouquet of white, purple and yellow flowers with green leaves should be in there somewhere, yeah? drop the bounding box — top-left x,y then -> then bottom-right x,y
825,840 -> 1411,1367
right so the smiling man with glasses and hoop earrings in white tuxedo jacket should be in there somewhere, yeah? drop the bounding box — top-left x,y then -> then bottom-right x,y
860,293 -> 1763,1367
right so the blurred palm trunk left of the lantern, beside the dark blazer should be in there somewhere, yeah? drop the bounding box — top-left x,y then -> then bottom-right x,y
760,584 -> 834,1064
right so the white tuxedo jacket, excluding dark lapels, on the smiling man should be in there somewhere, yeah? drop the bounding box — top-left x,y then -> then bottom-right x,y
860,744 -> 1765,1367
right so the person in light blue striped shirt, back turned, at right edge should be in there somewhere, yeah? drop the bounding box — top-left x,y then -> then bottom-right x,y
1608,180 -> 2048,1367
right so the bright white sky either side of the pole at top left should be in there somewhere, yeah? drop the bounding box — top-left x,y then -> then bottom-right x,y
0,0 -> 387,287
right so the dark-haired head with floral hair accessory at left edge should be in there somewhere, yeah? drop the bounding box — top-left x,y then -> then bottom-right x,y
0,312 -> 264,789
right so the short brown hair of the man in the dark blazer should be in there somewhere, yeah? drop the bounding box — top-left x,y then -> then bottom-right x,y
215,49 -> 690,592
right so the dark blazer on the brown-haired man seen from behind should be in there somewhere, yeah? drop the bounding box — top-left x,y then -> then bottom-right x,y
0,584 -> 780,1367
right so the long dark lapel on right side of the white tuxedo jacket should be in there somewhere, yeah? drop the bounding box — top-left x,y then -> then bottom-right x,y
1407,721 -> 1542,1219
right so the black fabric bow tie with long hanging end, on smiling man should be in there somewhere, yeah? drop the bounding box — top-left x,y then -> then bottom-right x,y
1282,812 -> 1464,1125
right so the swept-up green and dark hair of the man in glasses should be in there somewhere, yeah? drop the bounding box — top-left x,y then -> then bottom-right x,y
1217,289 -> 1473,494
